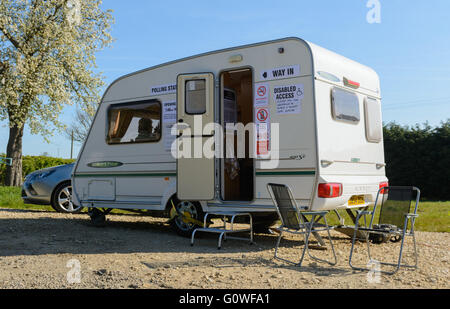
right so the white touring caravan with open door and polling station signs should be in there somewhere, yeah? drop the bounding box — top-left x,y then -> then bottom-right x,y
72,38 -> 387,234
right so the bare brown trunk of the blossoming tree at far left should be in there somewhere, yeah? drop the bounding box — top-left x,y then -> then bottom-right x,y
5,125 -> 24,187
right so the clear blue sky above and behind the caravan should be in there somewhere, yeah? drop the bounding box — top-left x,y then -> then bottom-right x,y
0,0 -> 450,158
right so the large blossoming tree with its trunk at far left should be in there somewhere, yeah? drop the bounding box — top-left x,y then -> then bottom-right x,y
0,0 -> 113,186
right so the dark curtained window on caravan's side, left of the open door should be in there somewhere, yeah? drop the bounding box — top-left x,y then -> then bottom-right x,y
107,100 -> 161,144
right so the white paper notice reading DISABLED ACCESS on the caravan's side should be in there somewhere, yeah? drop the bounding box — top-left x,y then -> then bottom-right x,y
273,84 -> 305,114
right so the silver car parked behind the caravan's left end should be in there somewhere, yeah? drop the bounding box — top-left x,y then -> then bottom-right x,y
22,163 -> 82,213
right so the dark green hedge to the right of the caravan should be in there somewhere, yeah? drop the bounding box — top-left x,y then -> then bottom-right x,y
384,120 -> 450,200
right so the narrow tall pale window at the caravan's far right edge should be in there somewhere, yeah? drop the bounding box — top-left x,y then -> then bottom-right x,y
364,98 -> 383,143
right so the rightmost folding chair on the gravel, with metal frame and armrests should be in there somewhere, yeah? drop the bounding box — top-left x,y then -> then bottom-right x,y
349,187 -> 420,275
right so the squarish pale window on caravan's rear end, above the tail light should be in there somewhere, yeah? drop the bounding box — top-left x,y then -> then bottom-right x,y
331,88 -> 361,123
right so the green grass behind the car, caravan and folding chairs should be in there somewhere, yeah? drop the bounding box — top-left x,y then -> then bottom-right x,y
0,186 -> 450,233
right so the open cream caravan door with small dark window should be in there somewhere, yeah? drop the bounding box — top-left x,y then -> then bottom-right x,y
177,73 -> 215,201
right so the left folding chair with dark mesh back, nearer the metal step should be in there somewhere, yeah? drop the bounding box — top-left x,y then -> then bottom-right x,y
267,183 -> 337,267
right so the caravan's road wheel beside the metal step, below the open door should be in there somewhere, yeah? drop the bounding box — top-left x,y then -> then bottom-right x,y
170,198 -> 204,237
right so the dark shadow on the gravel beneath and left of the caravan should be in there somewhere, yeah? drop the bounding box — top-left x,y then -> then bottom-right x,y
0,210 -> 352,267
